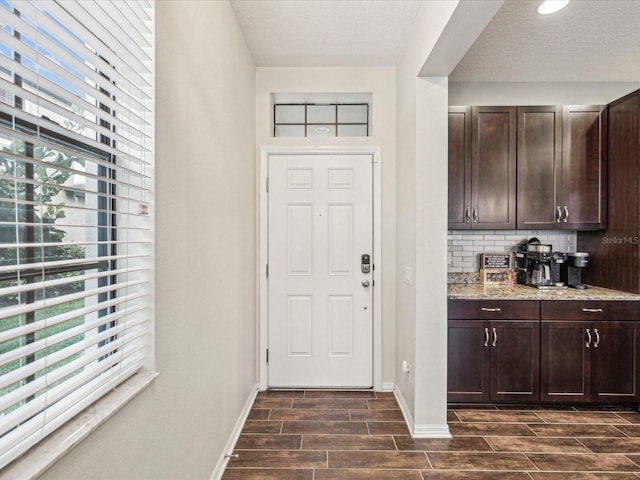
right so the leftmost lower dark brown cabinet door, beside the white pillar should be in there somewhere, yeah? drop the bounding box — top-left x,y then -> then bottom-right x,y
447,320 -> 489,402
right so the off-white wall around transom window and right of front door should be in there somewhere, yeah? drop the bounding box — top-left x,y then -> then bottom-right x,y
256,67 -> 396,387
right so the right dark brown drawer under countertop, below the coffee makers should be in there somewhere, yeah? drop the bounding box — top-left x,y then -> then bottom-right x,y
540,300 -> 640,320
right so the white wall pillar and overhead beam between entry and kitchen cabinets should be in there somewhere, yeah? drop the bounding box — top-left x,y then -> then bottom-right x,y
396,0 -> 502,437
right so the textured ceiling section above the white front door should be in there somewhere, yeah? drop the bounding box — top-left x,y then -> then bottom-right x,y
231,0 -> 422,67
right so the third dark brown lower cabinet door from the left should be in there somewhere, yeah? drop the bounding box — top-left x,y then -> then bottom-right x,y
540,322 -> 594,402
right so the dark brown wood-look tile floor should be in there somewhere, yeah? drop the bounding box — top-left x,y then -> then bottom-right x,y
223,390 -> 640,480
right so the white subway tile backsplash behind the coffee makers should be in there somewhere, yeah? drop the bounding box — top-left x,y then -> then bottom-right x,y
447,230 -> 577,273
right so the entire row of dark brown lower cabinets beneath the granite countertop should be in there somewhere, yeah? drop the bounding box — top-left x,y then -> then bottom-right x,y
447,300 -> 640,404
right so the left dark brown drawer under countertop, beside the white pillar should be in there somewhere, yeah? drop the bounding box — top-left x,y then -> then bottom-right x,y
448,300 -> 540,320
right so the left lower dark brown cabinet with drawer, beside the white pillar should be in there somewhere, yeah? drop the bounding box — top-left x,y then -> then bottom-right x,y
448,300 -> 540,402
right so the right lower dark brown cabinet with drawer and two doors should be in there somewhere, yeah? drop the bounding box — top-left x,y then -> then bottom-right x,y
540,301 -> 640,403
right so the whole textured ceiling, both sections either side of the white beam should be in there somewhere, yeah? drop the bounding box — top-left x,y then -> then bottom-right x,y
231,0 -> 640,82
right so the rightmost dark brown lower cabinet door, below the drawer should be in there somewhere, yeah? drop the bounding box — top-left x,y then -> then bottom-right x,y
591,322 -> 640,402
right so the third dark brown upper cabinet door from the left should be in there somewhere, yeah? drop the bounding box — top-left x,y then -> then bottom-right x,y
517,106 -> 562,229
